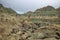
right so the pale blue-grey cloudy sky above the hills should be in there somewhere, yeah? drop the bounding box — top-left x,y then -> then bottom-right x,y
0,0 -> 60,13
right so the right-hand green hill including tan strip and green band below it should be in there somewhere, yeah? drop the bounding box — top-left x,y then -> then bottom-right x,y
23,6 -> 60,23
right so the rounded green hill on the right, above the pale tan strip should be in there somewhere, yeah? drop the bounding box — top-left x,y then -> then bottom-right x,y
25,6 -> 59,16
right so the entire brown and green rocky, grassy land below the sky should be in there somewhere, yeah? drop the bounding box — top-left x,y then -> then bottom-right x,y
0,4 -> 60,40
